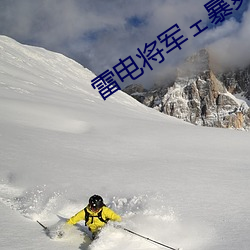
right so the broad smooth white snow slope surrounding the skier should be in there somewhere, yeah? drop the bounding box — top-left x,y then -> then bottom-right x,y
0,36 -> 250,250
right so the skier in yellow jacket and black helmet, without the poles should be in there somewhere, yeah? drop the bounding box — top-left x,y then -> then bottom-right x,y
67,194 -> 122,239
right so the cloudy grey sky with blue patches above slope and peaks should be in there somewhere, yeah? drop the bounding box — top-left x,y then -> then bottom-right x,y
0,0 -> 250,87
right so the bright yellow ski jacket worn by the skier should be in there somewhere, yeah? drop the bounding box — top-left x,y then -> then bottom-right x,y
67,206 -> 122,233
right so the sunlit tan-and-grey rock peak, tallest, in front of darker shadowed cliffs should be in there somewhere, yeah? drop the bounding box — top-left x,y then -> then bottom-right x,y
161,50 -> 250,129
